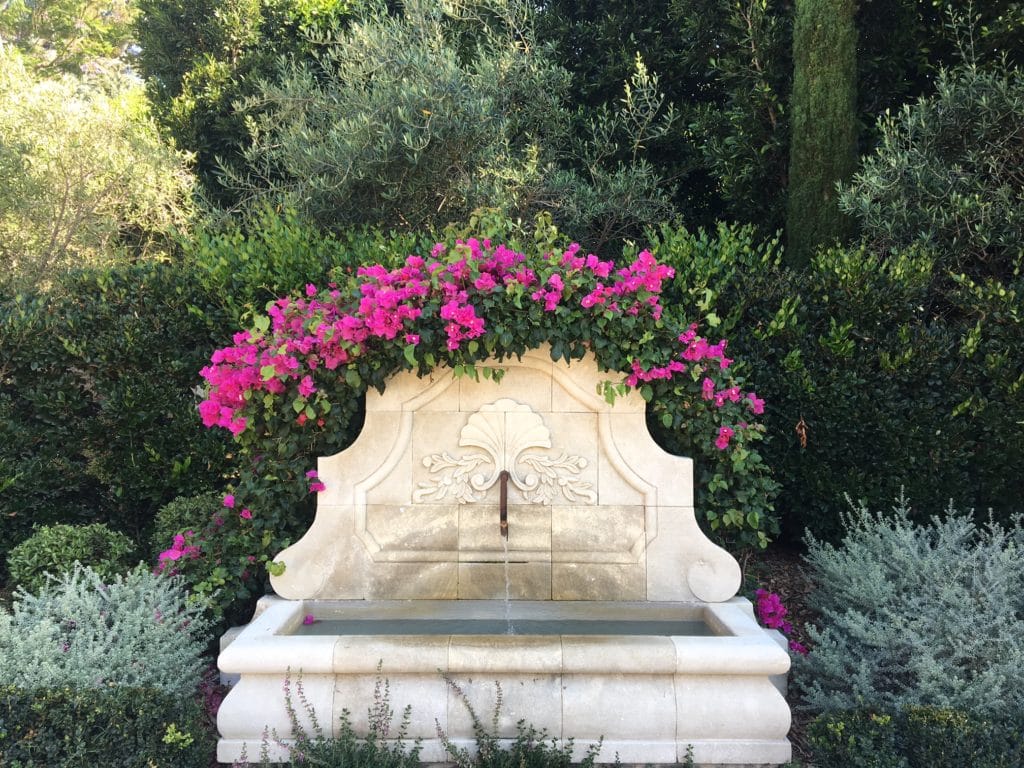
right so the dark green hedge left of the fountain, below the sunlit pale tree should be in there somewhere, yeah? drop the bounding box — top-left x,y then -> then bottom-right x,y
0,263 -> 230,556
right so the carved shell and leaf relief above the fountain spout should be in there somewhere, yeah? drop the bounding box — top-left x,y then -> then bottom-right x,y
413,397 -> 597,504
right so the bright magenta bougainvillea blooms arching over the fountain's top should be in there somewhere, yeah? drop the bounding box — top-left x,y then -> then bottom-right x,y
199,238 -> 700,444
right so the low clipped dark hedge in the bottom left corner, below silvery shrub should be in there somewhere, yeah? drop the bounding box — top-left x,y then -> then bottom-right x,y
0,687 -> 214,768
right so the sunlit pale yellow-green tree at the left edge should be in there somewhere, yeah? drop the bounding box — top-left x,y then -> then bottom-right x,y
0,49 -> 193,287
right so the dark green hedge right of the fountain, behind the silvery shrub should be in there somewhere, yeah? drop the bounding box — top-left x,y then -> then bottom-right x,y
656,226 -> 1024,542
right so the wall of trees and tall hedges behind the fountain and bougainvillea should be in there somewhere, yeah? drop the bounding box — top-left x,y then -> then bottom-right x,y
0,0 -> 1024,565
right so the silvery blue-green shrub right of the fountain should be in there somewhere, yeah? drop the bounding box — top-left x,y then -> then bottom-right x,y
795,498 -> 1024,718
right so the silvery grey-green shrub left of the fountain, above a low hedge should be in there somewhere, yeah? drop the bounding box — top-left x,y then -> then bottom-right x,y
0,563 -> 208,693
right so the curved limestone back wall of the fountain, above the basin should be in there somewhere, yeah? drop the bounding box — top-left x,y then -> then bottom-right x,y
271,349 -> 740,602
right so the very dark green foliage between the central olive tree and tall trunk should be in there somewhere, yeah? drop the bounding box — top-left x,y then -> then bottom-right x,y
538,0 -> 791,232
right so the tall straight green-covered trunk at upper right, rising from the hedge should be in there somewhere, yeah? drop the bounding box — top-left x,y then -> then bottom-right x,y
786,0 -> 857,266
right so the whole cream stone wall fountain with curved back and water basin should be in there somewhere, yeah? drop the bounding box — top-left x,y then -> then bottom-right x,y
218,349 -> 791,766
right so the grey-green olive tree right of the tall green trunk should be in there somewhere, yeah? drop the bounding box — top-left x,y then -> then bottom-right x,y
840,61 -> 1024,280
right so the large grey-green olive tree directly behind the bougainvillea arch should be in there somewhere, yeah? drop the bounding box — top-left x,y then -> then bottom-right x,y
223,0 -> 672,245
